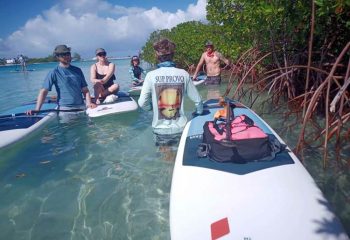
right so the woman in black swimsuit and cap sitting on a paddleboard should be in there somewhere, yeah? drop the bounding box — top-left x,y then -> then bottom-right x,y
90,48 -> 119,104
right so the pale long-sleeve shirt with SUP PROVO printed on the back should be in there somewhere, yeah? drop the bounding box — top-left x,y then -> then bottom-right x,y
138,67 -> 203,134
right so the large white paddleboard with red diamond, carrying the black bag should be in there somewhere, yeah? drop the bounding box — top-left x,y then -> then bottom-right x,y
170,100 -> 349,240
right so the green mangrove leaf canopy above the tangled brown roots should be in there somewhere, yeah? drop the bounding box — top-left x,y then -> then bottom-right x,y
142,0 -> 350,71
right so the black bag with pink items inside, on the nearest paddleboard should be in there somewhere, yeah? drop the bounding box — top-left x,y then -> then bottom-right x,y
197,101 -> 285,163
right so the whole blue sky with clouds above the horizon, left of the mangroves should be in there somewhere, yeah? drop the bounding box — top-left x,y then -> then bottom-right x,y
0,0 -> 207,59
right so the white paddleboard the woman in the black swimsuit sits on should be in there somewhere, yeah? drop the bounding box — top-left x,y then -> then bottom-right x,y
86,92 -> 138,117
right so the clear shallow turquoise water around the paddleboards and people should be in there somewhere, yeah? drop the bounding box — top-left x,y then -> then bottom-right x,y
0,60 -> 350,240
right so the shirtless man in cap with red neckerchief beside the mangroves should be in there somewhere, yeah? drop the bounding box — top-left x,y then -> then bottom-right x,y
193,41 -> 230,98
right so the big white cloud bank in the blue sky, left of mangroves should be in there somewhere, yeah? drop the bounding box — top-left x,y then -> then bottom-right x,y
0,0 -> 206,57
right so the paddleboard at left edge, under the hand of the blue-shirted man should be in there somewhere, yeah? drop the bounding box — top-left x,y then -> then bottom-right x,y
0,100 -> 57,148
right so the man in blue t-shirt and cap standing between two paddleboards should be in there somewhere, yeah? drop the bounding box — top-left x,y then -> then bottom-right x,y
27,45 -> 96,115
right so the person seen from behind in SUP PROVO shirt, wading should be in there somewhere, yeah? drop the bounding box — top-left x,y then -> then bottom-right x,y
138,39 -> 203,146
